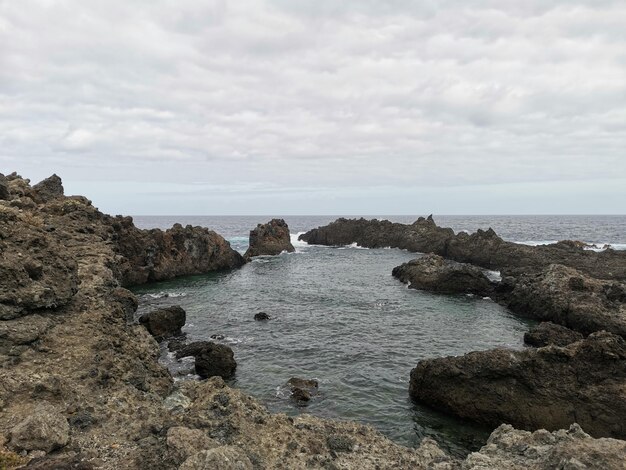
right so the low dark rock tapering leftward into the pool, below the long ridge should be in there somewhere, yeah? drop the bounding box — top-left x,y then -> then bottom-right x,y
392,254 -> 493,295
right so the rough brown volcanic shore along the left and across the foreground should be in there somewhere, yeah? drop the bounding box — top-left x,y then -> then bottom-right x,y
0,174 -> 626,470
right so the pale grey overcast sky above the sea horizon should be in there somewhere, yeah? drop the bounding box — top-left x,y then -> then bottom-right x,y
0,0 -> 626,215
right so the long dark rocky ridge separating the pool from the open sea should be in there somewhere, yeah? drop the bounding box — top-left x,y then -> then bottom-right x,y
299,217 -> 626,280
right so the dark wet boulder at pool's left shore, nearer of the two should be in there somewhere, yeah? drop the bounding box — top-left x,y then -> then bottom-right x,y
176,341 -> 237,379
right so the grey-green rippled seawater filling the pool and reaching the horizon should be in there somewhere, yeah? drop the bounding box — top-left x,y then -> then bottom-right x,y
134,214 -> 626,455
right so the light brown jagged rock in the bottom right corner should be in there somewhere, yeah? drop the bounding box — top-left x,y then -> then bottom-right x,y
462,424 -> 626,470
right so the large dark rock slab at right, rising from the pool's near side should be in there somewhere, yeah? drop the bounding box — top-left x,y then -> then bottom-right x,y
409,332 -> 626,439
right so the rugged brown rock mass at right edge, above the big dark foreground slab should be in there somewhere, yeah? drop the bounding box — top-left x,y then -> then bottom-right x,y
497,264 -> 626,337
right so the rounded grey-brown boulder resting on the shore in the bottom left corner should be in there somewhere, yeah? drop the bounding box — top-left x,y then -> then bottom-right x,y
11,403 -> 70,452
